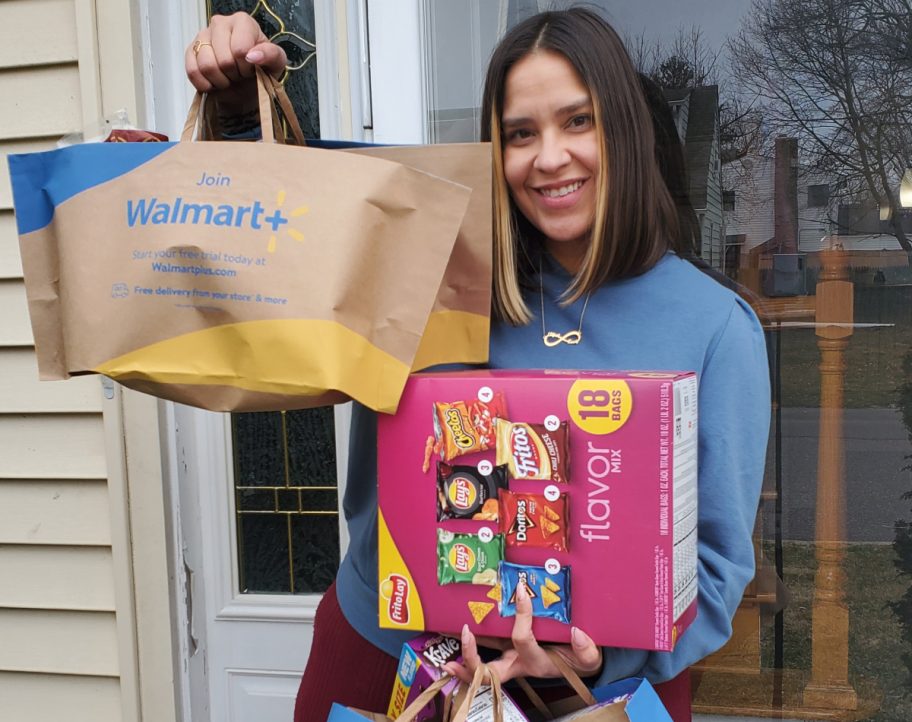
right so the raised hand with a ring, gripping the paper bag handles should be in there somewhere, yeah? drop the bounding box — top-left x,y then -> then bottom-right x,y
184,12 -> 287,115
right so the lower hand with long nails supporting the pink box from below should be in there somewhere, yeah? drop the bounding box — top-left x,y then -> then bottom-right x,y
445,584 -> 602,684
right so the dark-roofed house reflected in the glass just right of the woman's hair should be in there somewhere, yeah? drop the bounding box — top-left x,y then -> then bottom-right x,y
665,85 -> 724,270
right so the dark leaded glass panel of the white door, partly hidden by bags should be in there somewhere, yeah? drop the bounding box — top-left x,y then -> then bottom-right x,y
209,0 -> 339,594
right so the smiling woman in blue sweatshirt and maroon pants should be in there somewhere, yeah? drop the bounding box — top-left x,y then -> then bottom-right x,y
186,8 -> 769,722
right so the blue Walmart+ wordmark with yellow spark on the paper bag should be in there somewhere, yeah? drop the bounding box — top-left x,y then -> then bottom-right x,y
126,190 -> 310,253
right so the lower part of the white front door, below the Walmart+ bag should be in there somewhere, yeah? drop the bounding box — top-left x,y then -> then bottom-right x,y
170,405 -> 347,722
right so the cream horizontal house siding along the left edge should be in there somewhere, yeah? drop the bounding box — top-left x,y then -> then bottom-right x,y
0,0 -> 130,722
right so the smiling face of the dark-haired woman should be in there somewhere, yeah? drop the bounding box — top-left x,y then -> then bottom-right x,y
501,50 -> 599,270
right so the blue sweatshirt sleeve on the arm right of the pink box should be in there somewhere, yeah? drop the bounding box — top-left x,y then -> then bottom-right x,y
597,298 -> 770,685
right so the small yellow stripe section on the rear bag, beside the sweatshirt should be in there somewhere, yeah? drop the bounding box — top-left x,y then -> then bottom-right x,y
412,310 -> 491,371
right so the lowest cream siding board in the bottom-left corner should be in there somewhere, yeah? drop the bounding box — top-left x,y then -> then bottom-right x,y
0,672 -> 120,722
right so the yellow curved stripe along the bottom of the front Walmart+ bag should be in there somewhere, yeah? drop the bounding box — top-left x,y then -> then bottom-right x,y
92,319 -> 409,413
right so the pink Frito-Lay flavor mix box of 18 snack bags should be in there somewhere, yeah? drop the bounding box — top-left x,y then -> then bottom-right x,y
377,370 -> 697,651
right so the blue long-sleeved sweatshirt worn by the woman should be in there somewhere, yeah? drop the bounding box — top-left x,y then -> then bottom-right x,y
336,254 -> 770,684
